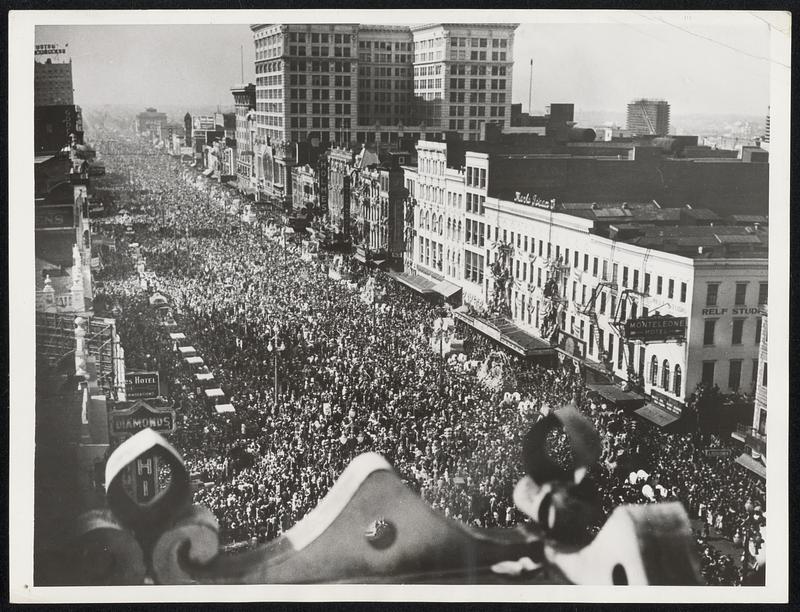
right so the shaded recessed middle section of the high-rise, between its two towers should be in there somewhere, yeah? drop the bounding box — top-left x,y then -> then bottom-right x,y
357,25 -> 414,126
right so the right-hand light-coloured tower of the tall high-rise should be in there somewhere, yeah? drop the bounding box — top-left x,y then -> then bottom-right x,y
411,23 -> 518,140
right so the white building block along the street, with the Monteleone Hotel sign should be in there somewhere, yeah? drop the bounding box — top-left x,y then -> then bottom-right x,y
405,142 -> 767,420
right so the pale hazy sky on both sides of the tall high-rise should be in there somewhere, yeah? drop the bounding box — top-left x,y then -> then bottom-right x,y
36,13 -> 770,116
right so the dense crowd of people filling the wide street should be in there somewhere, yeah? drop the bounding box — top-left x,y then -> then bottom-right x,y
87,140 -> 766,584
